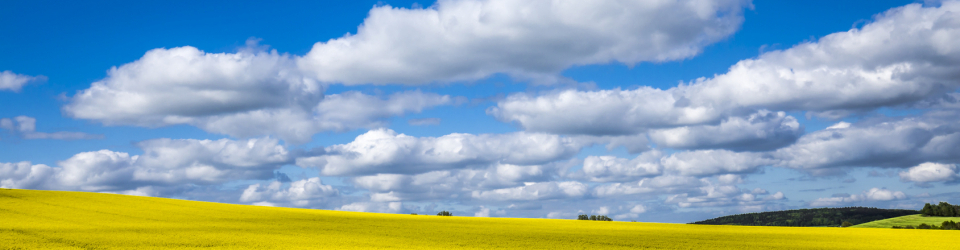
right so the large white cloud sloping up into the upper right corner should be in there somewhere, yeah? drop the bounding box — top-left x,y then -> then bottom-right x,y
680,2 -> 960,117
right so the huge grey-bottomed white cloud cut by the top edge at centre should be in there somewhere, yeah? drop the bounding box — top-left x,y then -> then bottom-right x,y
298,0 -> 749,85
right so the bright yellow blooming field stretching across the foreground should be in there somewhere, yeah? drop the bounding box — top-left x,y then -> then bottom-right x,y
0,189 -> 960,249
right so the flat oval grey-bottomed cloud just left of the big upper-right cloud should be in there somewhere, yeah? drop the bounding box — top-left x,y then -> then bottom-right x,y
487,87 -> 720,135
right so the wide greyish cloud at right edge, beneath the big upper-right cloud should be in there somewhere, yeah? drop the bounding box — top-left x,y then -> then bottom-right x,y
771,114 -> 960,170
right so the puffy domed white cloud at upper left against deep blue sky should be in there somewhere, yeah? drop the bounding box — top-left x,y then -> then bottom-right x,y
63,46 -> 323,126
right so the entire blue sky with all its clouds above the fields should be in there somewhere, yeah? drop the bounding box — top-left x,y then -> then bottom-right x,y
0,0 -> 960,223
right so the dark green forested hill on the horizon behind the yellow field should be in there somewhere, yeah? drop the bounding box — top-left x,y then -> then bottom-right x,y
690,207 -> 920,227
